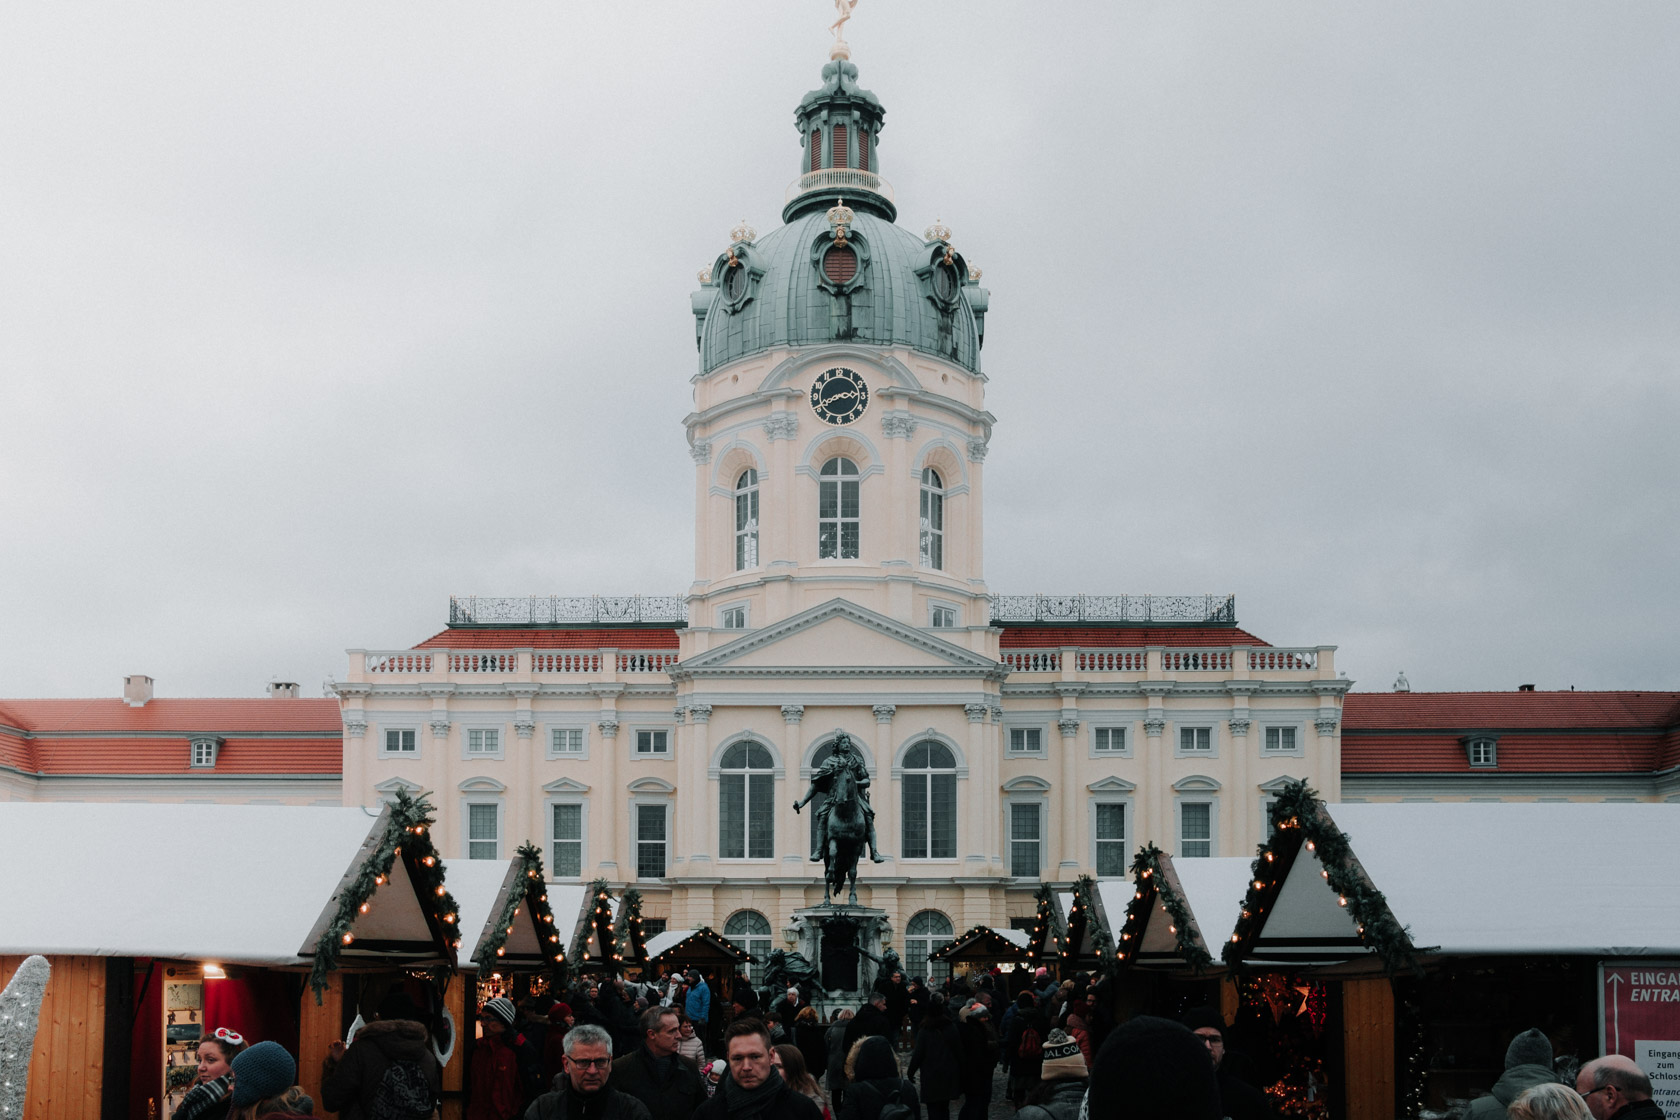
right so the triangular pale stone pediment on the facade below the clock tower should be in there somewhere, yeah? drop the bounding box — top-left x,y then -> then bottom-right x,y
679,599 -> 1001,677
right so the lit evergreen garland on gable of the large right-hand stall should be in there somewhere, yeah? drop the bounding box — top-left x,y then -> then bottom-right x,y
1225,781 -> 1420,976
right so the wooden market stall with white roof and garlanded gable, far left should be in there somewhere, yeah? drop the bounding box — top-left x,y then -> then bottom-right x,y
0,798 -> 459,1120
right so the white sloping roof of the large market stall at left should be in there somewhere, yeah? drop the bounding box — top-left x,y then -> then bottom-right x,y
0,801 -> 376,966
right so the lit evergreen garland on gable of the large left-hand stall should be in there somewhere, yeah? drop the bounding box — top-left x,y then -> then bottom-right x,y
309,789 -> 460,1006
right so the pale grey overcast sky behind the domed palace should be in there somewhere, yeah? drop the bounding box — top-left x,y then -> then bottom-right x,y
0,0 -> 1680,697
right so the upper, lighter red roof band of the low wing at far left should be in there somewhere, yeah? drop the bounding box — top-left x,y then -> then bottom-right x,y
0,697 -> 344,735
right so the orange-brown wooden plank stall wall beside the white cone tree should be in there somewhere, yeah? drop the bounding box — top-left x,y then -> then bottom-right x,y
0,957 -> 106,1120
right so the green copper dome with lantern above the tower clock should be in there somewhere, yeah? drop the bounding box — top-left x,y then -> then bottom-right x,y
694,60 -> 988,373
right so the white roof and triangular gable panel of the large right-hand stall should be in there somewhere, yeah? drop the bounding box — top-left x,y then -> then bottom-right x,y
1243,803 -> 1680,962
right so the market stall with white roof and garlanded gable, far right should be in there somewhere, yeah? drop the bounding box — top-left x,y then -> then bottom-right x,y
1225,784 -> 1680,1120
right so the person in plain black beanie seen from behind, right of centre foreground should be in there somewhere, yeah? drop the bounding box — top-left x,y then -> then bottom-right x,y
1085,1014 -> 1225,1120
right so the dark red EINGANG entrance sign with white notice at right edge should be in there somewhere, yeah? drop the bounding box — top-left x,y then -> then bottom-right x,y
1598,960 -> 1680,1117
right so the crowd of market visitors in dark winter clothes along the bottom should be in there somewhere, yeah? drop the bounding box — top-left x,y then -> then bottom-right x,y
173,969 -> 1663,1120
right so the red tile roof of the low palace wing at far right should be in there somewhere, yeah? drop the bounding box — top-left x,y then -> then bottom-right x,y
1342,692 -> 1680,774
